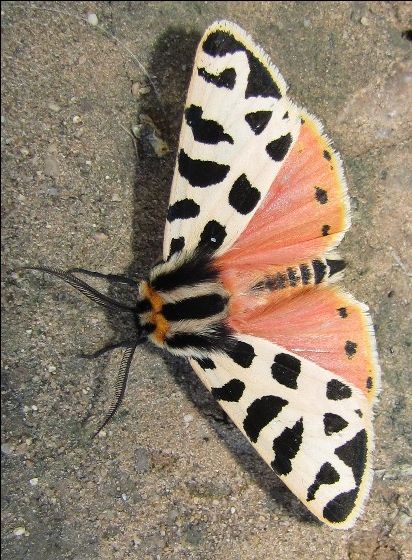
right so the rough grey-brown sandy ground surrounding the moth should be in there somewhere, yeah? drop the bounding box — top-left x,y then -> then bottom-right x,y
1,2 -> 412,560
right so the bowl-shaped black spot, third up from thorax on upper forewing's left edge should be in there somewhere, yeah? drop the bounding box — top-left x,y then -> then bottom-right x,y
178,150 -> 230,188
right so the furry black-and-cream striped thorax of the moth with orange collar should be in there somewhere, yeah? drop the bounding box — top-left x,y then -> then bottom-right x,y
136,254 -> 230,356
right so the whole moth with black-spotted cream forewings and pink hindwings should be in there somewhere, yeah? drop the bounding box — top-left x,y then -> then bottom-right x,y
30,21 -> 379,529
